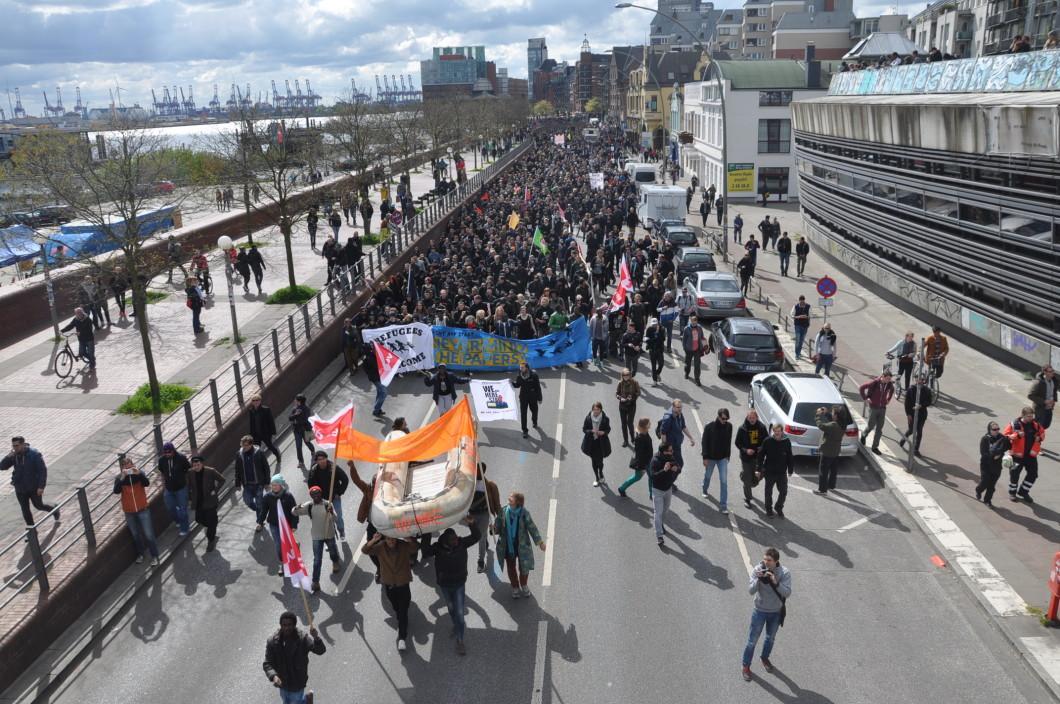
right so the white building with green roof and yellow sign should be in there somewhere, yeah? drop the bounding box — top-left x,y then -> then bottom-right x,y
679,57 -> 829,203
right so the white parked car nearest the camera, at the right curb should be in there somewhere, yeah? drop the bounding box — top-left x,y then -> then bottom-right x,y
747,372 -> 858,457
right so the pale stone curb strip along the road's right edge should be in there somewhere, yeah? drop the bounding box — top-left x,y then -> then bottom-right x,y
776,307 -> 1060,702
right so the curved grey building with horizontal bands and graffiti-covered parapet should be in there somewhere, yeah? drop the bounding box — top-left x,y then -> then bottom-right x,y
792,51 -> 1060,366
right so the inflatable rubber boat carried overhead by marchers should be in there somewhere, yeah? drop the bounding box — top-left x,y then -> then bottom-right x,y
370,430 -> 478,538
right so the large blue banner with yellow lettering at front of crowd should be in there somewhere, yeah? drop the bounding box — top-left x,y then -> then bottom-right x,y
431,318 -> 593,371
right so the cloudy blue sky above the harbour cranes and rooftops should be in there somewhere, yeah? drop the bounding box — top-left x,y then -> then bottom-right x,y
0,0 -> 923,116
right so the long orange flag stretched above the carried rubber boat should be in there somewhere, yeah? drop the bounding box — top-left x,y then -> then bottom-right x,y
335,395 -> 475,463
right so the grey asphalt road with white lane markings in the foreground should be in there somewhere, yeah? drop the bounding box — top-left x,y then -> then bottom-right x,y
35,343 -> 1052,704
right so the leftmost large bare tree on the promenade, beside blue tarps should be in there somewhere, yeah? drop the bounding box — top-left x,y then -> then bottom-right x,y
14,113 -> 193,418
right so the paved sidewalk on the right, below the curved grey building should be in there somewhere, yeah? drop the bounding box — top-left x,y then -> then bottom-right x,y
678,179 -> 1060,690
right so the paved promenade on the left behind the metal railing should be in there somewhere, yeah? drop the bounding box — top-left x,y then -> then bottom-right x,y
0,157 -> 451,534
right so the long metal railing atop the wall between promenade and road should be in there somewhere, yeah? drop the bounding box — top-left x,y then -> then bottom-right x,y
0,137 -> 533,611
